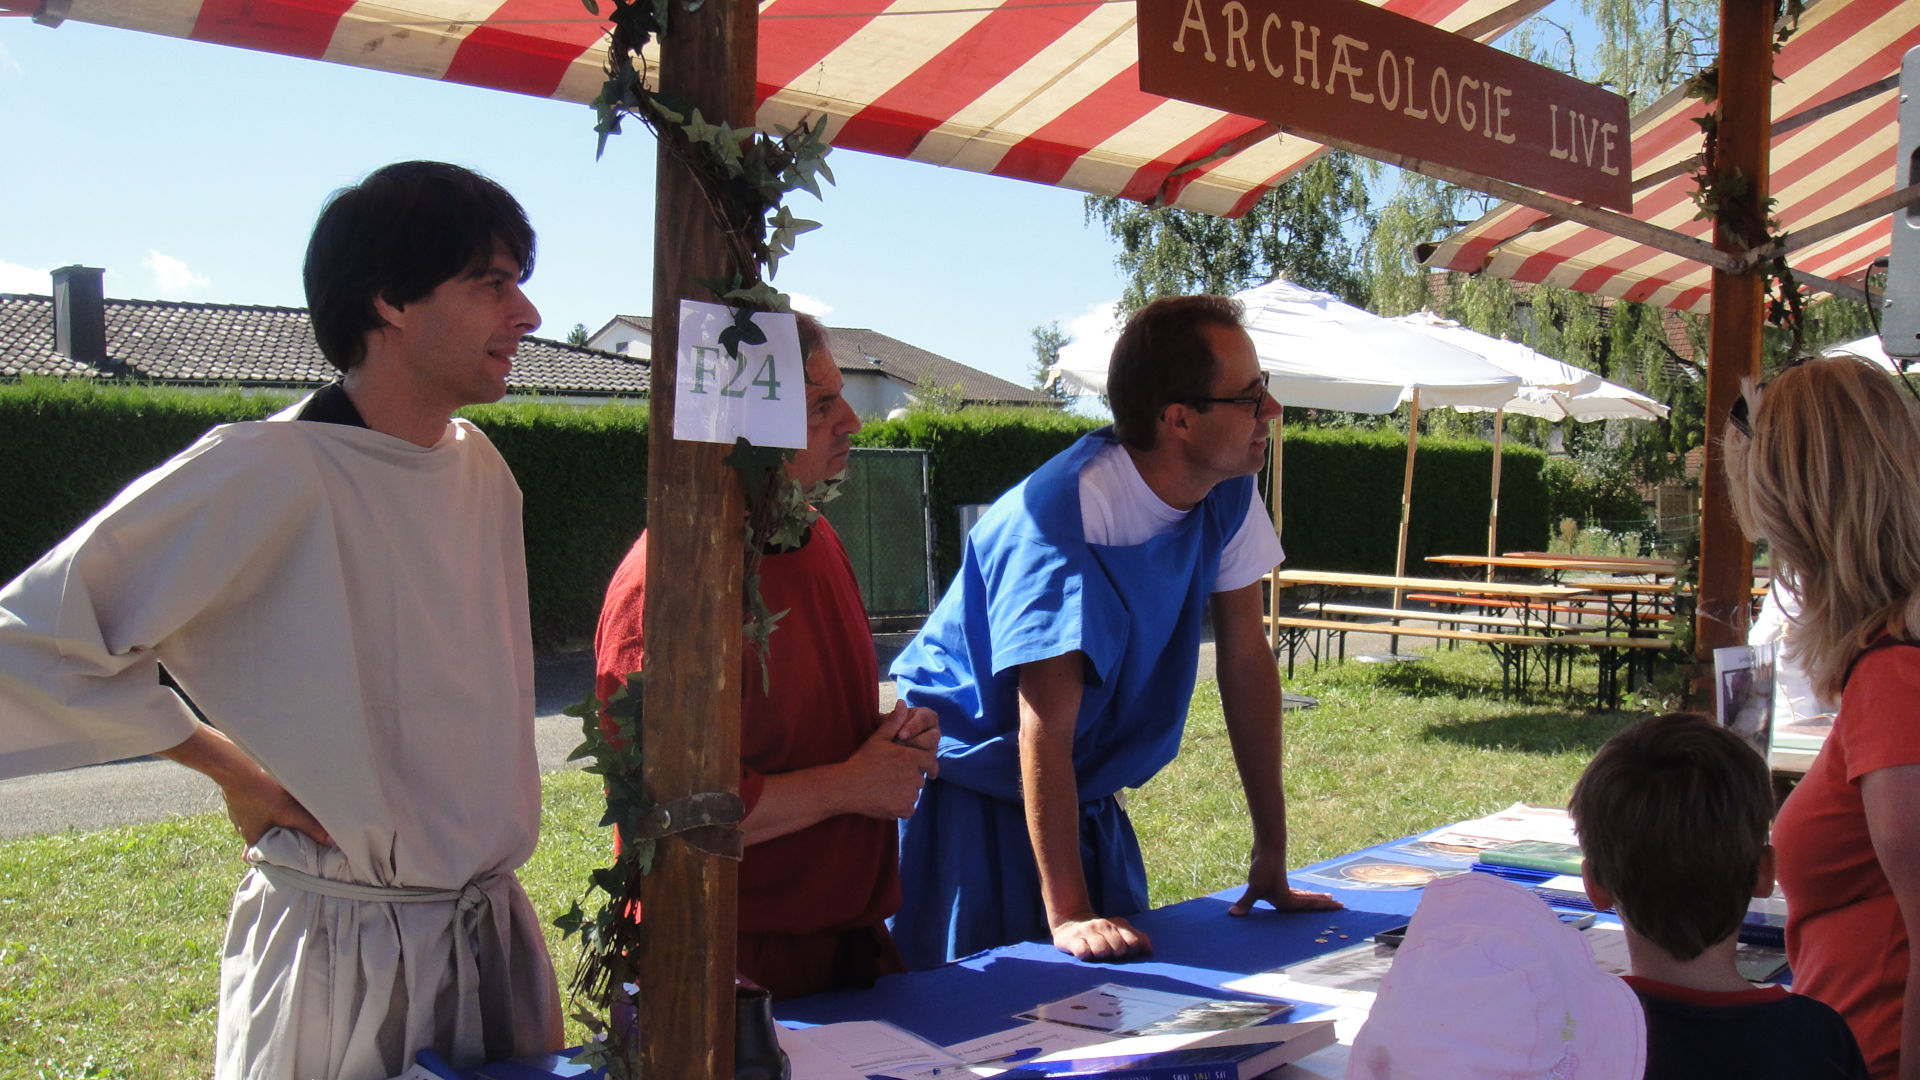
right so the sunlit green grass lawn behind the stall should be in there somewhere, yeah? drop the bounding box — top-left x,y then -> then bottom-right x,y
0,650 -> 1645,1080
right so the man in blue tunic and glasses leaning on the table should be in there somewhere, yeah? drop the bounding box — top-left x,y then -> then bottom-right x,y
893,296 -> 1338,967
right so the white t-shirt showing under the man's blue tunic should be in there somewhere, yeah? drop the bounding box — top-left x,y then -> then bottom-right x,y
1081,442 -> 1286,592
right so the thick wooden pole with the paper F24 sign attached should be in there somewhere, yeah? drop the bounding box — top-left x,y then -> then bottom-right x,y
639,0 -> 756,1080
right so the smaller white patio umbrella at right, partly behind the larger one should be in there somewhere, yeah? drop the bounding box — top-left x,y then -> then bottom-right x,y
1394,311 -> 1667,580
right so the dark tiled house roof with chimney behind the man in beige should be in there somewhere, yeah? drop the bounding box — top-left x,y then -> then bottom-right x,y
0,267 -> 649,404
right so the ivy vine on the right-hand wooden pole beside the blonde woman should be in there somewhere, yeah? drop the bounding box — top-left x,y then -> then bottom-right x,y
1686,0 -> 1807,354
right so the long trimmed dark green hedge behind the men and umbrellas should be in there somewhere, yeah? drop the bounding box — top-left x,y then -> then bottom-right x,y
0,379 -> 1548,650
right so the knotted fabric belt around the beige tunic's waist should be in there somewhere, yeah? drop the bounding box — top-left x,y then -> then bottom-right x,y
252,861 -> 515,1061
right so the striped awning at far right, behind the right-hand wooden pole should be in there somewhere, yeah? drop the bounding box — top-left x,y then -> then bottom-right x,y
1425,0 -> 1920,313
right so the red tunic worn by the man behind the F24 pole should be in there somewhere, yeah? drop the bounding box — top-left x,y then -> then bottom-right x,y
593,519 -> 902,997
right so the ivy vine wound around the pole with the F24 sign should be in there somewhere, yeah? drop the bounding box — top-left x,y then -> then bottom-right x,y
555,0 -> 833,1060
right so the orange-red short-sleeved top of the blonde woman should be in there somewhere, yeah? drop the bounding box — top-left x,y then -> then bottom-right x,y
1774,648 -> 1920,1076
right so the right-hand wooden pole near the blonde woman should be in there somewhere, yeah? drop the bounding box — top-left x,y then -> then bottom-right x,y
1693,0 -> 1774,680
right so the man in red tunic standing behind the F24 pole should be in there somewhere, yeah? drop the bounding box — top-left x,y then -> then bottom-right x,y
593,315 -> 941,997
